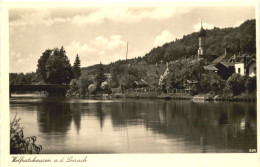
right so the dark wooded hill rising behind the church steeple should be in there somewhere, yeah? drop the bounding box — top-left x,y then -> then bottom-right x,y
143,20 -> 256,64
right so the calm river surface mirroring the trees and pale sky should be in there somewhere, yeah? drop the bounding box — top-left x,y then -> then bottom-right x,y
10,94 -> 257,154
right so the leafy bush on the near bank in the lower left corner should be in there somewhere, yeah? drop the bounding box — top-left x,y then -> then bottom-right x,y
10,115 -> 42,154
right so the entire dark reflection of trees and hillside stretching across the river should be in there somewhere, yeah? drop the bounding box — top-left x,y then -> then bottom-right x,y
38,100 -> 256,152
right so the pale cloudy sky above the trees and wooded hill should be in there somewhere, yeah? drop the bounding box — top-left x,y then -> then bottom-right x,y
9,5 -> 255,73
